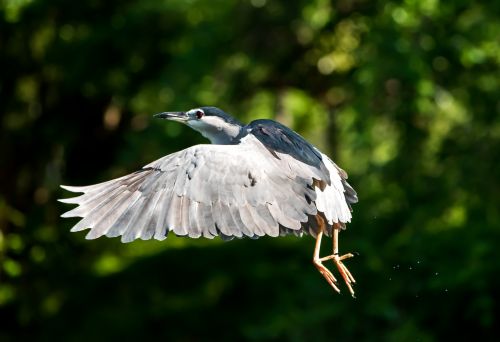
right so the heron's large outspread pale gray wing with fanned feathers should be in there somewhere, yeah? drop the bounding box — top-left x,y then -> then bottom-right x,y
61,135 -> 328,242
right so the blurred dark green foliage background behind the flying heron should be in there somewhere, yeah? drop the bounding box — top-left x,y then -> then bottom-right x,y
0,0 -> 500,341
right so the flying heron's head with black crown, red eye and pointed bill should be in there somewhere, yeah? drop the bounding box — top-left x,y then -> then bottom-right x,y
155,107 -> 243,144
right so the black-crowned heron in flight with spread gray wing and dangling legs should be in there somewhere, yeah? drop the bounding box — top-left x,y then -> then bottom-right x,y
60,107 -> 358,297
